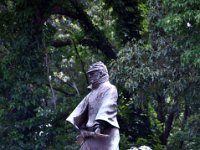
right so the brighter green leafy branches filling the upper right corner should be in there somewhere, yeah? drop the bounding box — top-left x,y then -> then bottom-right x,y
159,0 -> 200,67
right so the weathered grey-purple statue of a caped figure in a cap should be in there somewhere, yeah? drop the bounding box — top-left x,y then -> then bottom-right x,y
66,62 -> 120,150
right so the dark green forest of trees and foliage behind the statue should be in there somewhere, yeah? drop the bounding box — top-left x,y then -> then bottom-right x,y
0,0 -> 200,150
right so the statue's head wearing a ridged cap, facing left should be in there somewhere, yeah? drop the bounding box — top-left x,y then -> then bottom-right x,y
87,61 -> 109,85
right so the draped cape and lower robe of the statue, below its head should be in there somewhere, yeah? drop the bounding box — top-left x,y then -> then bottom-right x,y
66,81 -> 120,150
